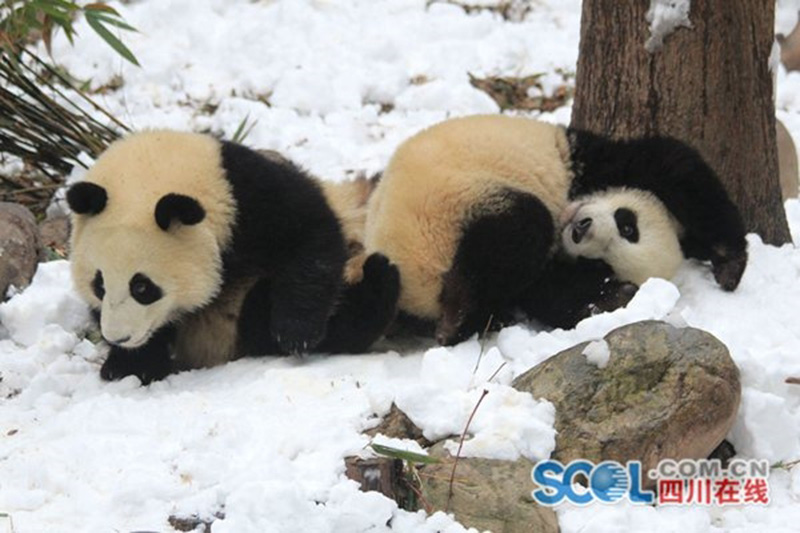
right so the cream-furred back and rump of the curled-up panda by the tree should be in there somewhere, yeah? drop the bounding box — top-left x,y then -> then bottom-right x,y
365,115 -> 571,318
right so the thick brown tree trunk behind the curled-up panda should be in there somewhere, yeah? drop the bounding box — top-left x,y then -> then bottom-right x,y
572,0 -> 791,244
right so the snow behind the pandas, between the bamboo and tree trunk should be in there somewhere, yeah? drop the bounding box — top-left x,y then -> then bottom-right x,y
45,0 -> 580,179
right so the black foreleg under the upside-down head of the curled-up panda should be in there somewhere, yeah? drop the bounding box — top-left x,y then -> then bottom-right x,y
518,254 -> 638,329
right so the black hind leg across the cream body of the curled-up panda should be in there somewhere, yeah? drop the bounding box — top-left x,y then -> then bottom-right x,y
436,189 -> 555,345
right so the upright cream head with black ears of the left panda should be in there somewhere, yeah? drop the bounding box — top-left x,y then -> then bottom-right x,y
67,132 -> 232,349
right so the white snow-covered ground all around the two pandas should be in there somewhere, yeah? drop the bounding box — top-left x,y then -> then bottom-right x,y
0,0 -> 800,533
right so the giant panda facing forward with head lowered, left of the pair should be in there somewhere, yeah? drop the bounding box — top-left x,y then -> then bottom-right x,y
67,131 -> 399,383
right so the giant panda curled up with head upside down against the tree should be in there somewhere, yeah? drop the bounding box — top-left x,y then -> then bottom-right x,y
365,115 -> 747,344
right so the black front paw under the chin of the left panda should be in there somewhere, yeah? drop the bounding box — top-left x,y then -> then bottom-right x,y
100,326 -> 175,385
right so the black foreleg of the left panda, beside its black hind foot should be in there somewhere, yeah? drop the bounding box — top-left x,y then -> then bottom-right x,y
269,234 -> 346,354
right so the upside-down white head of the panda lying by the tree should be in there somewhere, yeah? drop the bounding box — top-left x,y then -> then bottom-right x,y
561,188 -> 683,285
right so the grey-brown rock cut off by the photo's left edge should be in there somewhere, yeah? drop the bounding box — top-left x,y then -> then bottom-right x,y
0,202 -> 39,301
